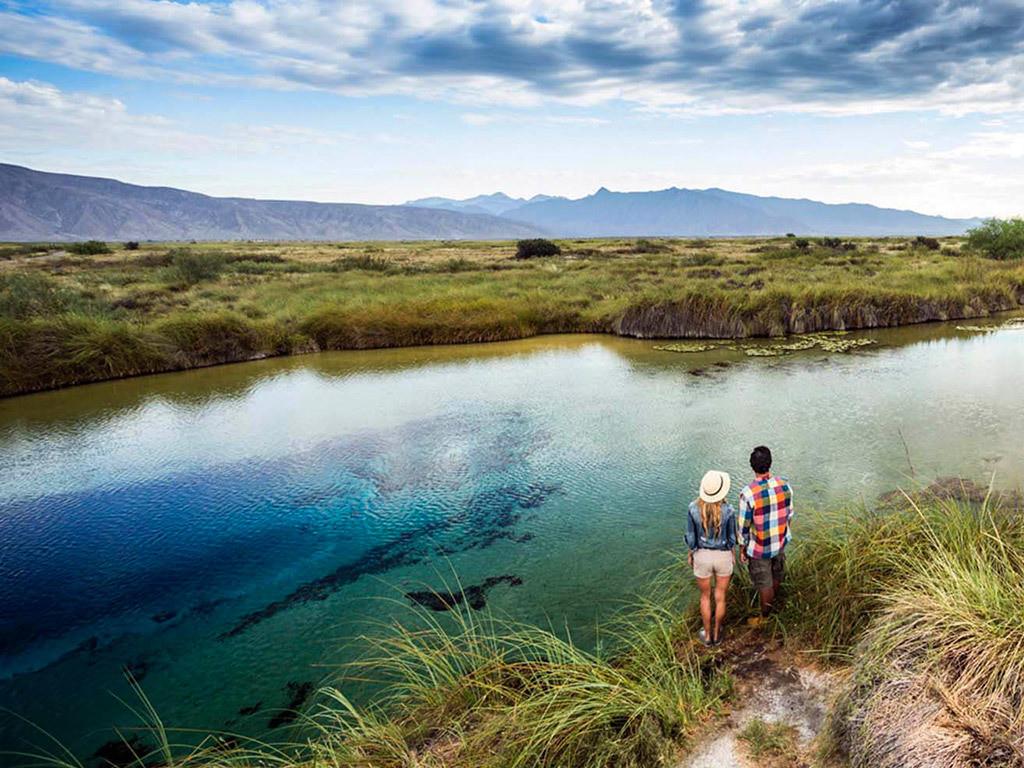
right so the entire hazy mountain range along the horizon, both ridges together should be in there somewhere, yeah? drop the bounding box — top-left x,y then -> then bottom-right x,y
0,164 -> 979,241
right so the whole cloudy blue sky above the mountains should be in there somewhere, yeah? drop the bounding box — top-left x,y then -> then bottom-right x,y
0,0 -> 1024,216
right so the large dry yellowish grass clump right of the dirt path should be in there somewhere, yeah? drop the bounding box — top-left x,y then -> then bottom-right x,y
802,499 -> 1024,768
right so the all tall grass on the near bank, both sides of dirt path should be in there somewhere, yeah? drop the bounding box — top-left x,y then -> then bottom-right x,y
19,481 -> 1024,768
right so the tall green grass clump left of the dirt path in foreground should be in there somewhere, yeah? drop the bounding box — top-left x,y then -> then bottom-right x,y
312,593 -> 729,768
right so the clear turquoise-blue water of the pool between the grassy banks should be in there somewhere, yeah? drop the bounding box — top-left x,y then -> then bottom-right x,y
0,325 -> 1024,757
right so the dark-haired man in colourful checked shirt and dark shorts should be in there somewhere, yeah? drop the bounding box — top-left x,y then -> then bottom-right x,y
737,445 -> 793,616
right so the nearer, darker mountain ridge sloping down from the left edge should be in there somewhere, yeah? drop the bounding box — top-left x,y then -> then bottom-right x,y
0,164 -> 542,241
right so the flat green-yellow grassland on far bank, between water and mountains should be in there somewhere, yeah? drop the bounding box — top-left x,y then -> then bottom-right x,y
0,239 -> 1024,395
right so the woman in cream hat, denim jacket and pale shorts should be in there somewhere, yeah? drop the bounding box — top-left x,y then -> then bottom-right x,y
686,469 -> 736,645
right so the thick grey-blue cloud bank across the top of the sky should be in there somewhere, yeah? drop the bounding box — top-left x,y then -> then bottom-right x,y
0,0 -> 1024,115
